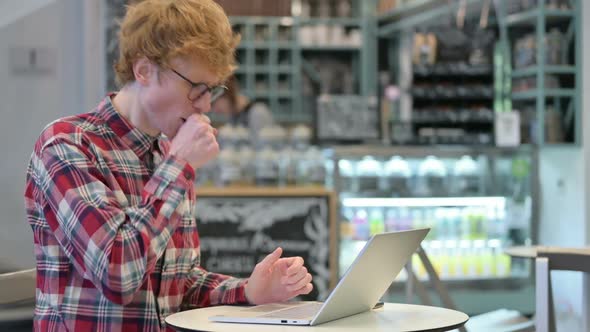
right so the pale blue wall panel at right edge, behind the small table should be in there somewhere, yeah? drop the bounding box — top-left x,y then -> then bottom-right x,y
539,147 -> 586,330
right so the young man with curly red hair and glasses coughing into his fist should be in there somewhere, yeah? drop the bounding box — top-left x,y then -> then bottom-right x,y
25,0 -> 312,332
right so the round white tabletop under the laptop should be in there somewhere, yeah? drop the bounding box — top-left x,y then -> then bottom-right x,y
166,303 -> 469,332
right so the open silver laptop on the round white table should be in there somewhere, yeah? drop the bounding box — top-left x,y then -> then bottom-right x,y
209,228 -> 430,325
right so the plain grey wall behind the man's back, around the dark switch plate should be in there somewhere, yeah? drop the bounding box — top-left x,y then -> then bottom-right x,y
0,0 -> 85,268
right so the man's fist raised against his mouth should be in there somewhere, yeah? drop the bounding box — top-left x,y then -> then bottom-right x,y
170,114 -> 219,169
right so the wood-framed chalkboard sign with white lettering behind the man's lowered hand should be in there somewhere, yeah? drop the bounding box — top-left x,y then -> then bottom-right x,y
196,188 -> 337,300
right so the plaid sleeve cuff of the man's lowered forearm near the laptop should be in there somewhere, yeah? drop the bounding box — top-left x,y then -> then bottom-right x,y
182,265 -> 248,309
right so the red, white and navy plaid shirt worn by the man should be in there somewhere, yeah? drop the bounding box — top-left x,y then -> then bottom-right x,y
25,96 -> 246,332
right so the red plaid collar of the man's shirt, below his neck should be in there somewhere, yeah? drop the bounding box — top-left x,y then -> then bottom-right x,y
98,93 -> 160,158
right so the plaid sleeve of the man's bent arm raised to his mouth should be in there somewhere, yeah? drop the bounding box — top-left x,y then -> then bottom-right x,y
32,137 -> 194,305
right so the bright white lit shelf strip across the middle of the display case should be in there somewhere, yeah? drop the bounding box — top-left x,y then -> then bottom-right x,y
342,196 -> 506,208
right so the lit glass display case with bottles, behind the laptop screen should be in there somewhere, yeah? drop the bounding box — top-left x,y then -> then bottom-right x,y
331,146 -> 537,312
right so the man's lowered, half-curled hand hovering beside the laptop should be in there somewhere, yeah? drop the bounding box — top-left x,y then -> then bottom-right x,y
245,248 -> 313,304
